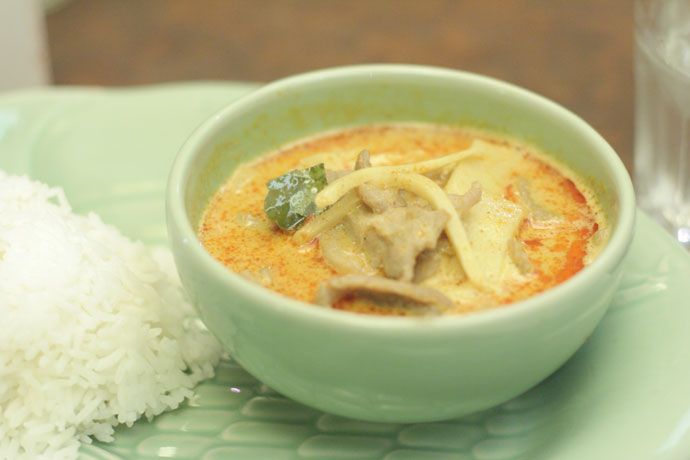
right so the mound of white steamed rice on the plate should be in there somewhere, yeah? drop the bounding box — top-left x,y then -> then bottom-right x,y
0,171 -> 220,460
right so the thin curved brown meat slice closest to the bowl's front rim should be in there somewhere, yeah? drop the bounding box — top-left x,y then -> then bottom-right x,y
315,275 -> 453,307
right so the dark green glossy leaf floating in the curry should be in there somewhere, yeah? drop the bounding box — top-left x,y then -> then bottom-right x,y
264,163 -> 327,230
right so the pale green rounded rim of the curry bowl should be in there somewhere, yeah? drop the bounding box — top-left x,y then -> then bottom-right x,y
166,64 -> 636,333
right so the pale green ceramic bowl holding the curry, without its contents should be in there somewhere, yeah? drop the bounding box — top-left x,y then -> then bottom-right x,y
167,65 -> 635,422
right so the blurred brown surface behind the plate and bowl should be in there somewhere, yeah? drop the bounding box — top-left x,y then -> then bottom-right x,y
10,0 -> 633,170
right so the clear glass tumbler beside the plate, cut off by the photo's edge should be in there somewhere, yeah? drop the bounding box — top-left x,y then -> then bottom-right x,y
634,0 -> 690,248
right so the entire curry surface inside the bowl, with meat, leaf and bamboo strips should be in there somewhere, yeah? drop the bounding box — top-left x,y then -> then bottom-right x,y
199,124 -> 608,315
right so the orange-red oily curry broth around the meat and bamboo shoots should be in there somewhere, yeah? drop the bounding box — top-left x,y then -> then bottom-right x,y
199,124 -> 604,315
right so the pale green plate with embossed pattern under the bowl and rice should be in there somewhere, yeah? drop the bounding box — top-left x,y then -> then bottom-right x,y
0,83 -> 690,460
